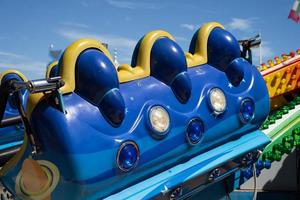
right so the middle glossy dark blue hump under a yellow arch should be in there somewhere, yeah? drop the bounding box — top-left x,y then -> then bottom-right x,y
150,38 -> 192,103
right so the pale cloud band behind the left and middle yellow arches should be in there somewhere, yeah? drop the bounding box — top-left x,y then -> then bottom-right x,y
58,30 -> 137,63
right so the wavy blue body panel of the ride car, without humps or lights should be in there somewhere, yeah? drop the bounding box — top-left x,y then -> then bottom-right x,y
18,60 -> 269,198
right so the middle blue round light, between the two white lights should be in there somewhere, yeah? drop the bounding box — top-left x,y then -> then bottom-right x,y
186,119 -> 204,145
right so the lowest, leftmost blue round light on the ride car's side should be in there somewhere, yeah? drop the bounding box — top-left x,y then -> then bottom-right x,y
117,142 -> 139,172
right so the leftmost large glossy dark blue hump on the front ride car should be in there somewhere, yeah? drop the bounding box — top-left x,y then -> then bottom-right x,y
75,49 -> 125,126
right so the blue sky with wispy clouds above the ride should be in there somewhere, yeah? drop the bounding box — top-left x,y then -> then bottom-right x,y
0,0 -> 300,78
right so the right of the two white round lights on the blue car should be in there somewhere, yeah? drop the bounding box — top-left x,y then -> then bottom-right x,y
209,88 -> 226,114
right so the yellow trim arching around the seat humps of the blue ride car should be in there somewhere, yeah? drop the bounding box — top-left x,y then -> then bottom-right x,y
27,22 -> 224,117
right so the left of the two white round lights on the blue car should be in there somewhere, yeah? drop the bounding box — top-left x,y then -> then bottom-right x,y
149,106 -> 170,136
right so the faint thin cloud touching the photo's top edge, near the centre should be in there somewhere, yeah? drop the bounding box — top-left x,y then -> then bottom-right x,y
106,0 -> 161,10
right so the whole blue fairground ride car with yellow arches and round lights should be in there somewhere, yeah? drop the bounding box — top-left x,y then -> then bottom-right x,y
0,23 -> 269,199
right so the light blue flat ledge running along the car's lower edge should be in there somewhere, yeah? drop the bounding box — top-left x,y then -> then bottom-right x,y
106,131 -> 270,200
